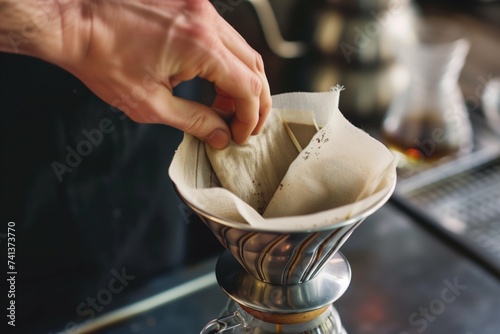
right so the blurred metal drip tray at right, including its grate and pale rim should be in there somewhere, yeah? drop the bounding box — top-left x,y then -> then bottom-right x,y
393,117 -> 500,276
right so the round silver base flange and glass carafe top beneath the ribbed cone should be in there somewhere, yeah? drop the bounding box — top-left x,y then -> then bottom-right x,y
201,251 -> 351,334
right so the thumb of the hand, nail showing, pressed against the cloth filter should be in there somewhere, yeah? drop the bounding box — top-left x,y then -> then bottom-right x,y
166,96 -> 231,149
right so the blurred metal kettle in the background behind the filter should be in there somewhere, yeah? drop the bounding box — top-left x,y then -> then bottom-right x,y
247,0 -> 418,122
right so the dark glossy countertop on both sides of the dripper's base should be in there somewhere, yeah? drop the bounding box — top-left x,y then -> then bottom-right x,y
69,203 -> 500,334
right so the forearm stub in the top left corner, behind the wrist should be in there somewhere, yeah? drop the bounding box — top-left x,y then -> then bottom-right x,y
0,0 -> 77,61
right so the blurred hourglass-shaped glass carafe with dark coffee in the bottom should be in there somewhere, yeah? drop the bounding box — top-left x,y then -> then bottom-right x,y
382,17 -> 473,162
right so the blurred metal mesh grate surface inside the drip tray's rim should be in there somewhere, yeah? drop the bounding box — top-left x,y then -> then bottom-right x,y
400,158 -> 500,273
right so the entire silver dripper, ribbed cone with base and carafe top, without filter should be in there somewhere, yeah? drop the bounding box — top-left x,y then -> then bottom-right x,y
175,174 -> 395,334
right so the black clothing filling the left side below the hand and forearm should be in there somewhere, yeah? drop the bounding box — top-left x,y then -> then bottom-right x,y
0,53 -> 220,333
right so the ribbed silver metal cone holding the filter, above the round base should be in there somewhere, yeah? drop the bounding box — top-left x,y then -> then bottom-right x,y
180,183 -> 393,285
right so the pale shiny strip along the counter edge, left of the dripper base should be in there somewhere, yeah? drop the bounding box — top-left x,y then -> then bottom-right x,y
58,272 -> 217,334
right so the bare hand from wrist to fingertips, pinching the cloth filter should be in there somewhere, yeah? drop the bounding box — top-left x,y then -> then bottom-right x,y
24,0 -> 271,148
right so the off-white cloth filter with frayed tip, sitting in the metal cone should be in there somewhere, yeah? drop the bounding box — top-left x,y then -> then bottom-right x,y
169,88 -> 397,231
